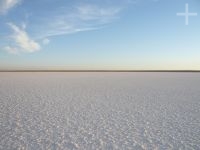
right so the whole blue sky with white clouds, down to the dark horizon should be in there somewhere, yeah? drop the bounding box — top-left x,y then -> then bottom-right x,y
0,0 -> 200,70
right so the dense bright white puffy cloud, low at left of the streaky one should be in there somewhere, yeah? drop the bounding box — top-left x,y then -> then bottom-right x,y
5,23 -> 40,53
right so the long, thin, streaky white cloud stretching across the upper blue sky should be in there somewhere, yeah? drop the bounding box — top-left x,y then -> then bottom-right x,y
34,4 -> 122,39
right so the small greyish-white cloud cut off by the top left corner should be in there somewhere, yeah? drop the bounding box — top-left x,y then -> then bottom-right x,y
0,0 -> 21,14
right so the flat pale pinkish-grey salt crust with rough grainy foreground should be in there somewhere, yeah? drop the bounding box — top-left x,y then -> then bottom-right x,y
0,72 -> 200,150
